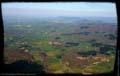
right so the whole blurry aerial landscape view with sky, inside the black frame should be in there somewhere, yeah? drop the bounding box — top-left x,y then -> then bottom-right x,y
2,2 -> 117,74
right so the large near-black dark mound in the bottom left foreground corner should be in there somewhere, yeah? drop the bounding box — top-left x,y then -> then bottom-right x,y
4,60 -> 45,73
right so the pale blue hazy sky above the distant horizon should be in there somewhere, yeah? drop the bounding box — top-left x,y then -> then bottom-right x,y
2,2 -> 116,17
